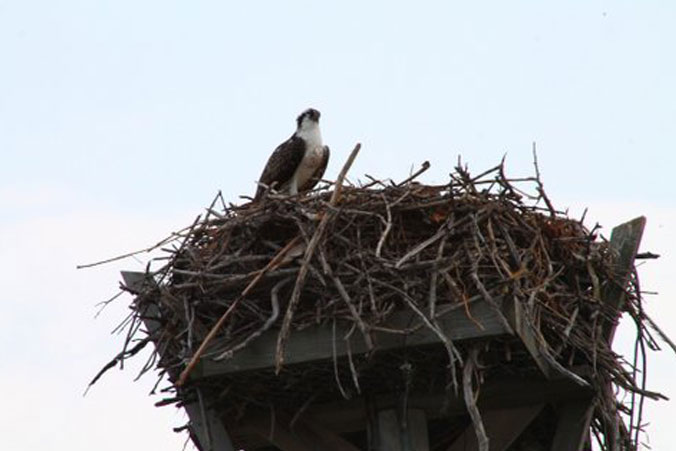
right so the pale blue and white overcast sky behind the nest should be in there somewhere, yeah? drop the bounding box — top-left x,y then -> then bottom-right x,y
0,0 -> 676,450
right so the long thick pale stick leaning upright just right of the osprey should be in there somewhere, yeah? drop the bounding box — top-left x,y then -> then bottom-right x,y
275,143 -> 361,373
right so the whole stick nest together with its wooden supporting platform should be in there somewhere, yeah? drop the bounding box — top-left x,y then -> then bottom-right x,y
103,165 -> 659,451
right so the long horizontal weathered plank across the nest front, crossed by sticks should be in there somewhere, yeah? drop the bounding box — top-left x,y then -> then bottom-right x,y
193,301 -> 508,377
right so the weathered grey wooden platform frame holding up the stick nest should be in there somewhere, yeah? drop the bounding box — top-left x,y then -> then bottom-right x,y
122,217 -> 645,451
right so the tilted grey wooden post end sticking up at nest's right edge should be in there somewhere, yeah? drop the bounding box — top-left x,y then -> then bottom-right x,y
602,216 -> 646,343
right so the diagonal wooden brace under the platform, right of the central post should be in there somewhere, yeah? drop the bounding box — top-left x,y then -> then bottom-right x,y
448,404 -> 545,451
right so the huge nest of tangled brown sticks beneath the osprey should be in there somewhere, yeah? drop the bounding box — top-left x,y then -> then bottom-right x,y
92,154 -> 668,449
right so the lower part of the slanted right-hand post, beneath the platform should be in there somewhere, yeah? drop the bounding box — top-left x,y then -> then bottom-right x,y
551,398 -> 594,451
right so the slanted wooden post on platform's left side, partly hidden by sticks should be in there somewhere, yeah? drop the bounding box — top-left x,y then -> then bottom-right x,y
121,271 -> 235,451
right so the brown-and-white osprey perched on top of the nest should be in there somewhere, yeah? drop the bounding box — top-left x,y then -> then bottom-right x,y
254,108 -> 329,200
